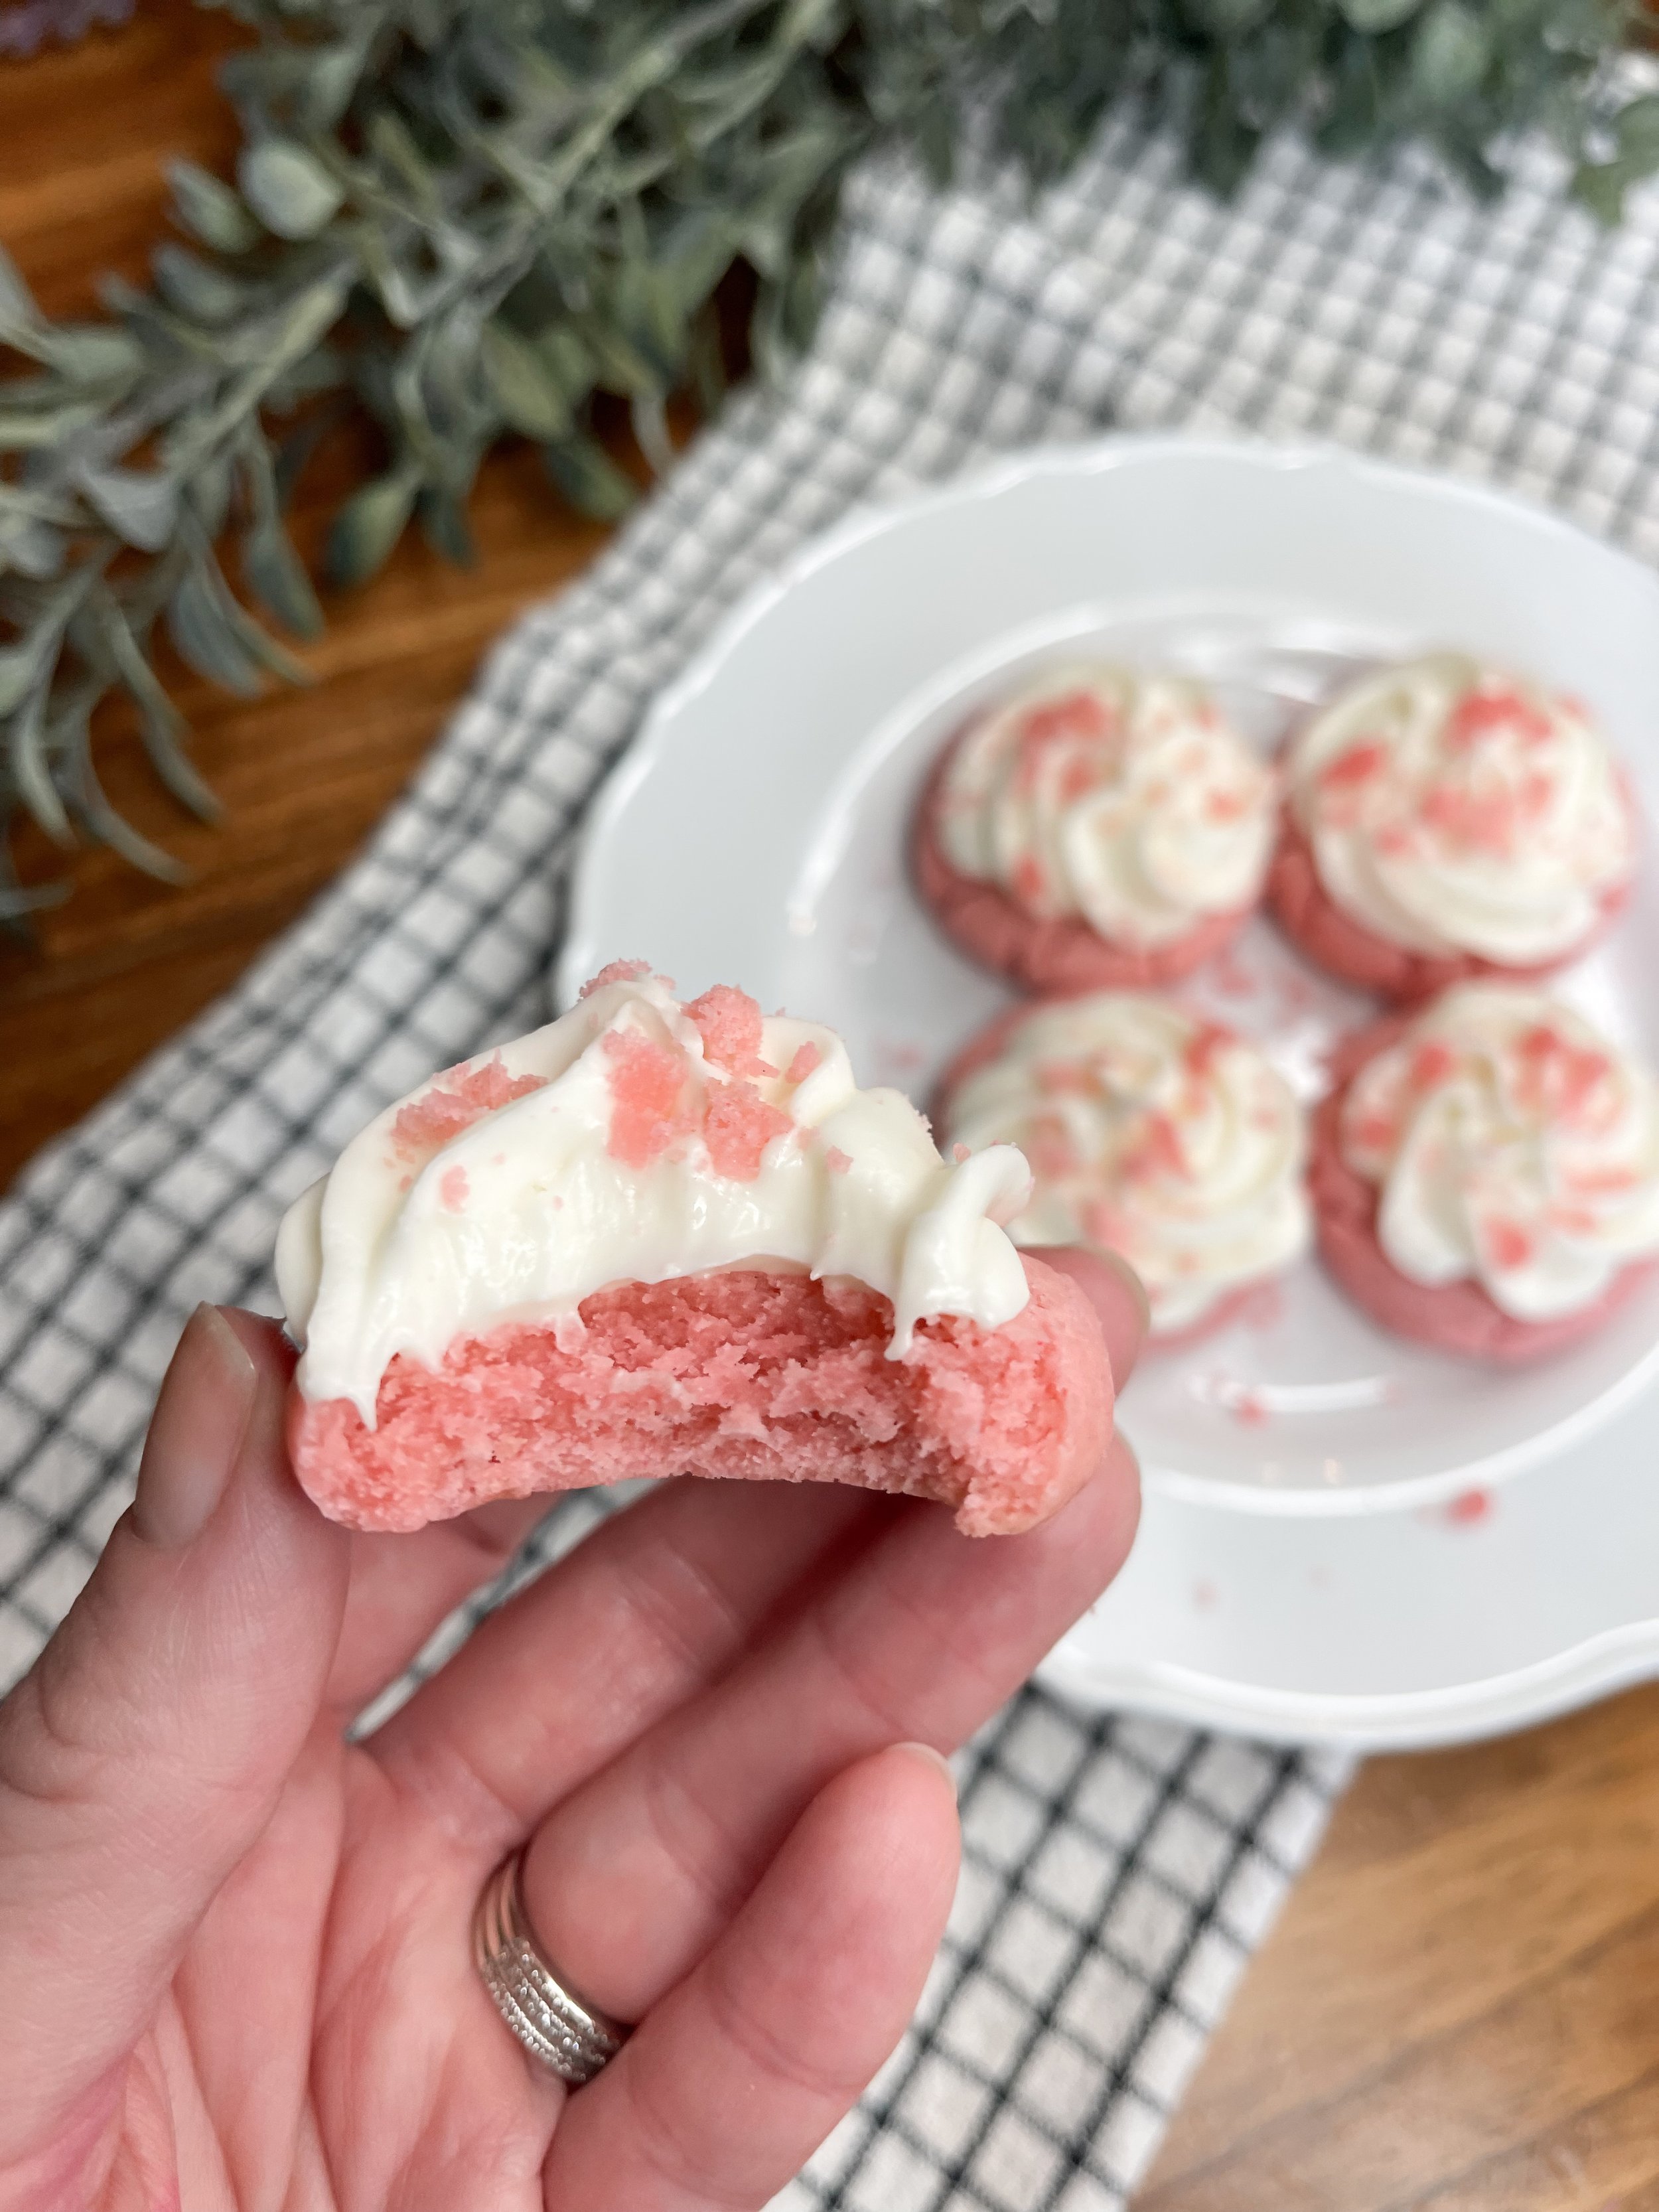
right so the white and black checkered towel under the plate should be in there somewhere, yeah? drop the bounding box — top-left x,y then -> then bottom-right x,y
0,104 -> 1659,2212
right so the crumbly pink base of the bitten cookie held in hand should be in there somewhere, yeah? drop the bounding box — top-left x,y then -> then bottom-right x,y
290,1261 -> 1113,1535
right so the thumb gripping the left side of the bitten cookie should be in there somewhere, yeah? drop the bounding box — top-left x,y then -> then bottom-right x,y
0,1305 -> 347,2164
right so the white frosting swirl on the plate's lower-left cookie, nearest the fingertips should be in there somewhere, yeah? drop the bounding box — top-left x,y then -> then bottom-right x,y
947,991 -> 1309,1334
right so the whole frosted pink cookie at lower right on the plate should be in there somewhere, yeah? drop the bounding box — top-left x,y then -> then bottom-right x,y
1309,982 -> 1659,1363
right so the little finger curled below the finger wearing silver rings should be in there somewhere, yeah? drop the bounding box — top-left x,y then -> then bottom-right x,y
544,1745 -> 958,2212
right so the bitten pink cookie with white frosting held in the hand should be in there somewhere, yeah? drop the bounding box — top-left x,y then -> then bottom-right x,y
279,962 -> 1113,1535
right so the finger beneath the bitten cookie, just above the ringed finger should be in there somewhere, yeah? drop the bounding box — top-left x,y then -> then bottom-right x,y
370,1482 -> 894,1856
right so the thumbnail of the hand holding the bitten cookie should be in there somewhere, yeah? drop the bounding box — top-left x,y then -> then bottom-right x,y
133,1305 -> 259,1550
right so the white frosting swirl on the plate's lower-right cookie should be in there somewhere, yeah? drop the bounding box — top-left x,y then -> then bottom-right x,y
1340,982 -> 1659,1321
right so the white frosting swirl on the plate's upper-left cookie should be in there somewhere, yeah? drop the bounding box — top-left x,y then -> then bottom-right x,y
936,662 -> 1279,947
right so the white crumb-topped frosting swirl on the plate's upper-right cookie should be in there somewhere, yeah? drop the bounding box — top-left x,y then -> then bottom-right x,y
1287,652 -> 1634,967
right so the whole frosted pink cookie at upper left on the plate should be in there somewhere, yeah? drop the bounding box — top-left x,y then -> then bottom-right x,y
911,664 -> 1276,994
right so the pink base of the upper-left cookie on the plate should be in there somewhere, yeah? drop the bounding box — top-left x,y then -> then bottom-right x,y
911,739 -> 1252,997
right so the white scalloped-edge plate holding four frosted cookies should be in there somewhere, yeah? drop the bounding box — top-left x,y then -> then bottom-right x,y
559,440 -> 1659,1743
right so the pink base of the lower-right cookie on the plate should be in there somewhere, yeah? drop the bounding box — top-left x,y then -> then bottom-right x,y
1307,1013 -> 1659,1367
